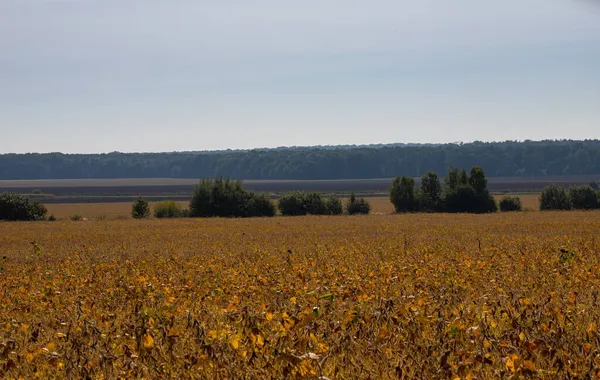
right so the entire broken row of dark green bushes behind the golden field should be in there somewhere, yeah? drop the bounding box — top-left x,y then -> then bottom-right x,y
0,176 -> 600,221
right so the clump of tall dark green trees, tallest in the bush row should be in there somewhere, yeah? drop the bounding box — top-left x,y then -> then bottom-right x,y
390,167 -> 500,213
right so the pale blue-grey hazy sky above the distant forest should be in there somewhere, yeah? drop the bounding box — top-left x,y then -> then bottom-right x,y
0,0 -> 600,153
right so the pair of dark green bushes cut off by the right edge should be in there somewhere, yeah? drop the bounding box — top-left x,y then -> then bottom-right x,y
540,184 -> 600,210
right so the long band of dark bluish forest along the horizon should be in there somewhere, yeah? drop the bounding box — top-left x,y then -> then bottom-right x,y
0,140 -> 600,180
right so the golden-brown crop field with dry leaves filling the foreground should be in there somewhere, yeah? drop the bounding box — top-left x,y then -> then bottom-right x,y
0,212 -> 600,379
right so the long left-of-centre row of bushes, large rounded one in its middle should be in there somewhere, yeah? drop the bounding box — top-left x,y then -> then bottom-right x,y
131,178 -> 371,219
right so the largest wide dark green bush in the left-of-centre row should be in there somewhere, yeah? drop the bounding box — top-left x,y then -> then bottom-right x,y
189,178 -> 275,218
